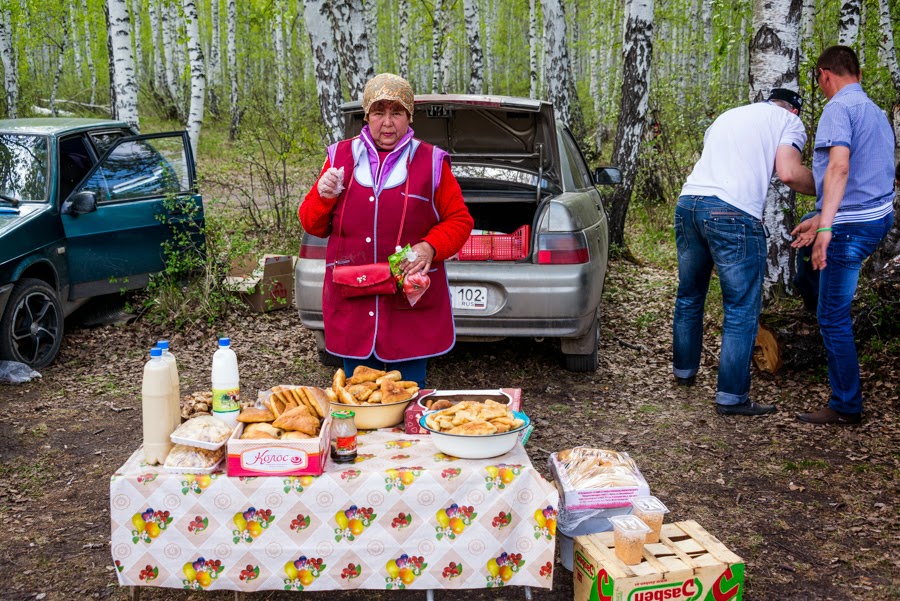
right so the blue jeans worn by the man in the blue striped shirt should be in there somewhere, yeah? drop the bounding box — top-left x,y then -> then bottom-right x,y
816,213 -> 894,413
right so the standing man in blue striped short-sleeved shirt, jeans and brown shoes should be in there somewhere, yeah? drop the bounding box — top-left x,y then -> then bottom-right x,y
793,46 -> 894,425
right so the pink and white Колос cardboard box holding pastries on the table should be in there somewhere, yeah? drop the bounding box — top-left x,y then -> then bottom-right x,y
226,413 -> 331,476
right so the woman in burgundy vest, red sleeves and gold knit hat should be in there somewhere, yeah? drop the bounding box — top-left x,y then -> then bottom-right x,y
298,73 -> 474,388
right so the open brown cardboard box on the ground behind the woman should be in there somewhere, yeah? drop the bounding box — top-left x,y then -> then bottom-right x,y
225,255 -> 296,313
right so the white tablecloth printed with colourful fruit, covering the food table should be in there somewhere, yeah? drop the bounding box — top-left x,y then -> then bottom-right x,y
110,431 -> 558,591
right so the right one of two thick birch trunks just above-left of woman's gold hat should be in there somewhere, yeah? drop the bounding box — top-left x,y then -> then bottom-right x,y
323,0 -> 375,100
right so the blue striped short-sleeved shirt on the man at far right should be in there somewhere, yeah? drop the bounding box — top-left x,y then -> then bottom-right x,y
813,83 -> 894,223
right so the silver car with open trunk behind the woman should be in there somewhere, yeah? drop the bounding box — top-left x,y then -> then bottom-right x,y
295,95 -> 621,371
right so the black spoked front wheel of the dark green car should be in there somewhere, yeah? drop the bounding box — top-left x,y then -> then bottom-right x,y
0,278 -> 63,368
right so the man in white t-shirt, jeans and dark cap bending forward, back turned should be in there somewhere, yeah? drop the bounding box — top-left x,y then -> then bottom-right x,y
672,88 -> 815,415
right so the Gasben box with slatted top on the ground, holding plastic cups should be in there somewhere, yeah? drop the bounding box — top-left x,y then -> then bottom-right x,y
574,521 -> 744,601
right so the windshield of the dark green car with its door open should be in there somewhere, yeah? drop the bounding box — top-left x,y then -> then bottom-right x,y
0,134 -> 48,202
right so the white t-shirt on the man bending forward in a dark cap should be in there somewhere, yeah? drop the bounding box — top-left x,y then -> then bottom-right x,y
681,102 -> 806,219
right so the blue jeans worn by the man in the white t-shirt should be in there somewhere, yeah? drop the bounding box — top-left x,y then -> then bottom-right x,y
672,196 -> 766,405
